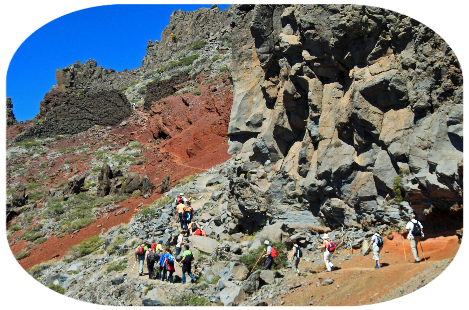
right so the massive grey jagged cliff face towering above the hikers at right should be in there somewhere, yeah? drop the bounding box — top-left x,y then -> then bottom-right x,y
229,0 -> 469,230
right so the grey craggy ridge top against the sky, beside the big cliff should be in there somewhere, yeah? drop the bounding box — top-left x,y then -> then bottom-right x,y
142,6 -> 231,70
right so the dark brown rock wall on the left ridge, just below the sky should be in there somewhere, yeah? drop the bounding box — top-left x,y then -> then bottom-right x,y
16,90 -> 132,140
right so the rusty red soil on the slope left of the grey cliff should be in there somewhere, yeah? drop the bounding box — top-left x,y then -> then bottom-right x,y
0,73 -> 233,290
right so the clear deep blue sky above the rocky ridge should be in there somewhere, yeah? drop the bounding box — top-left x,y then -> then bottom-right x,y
0,0 -> 230,121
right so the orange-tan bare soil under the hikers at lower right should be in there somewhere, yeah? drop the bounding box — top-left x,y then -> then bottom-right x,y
273,233 -> 467,309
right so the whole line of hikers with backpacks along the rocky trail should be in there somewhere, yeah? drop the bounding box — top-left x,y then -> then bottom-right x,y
136,193 -> 424,284
